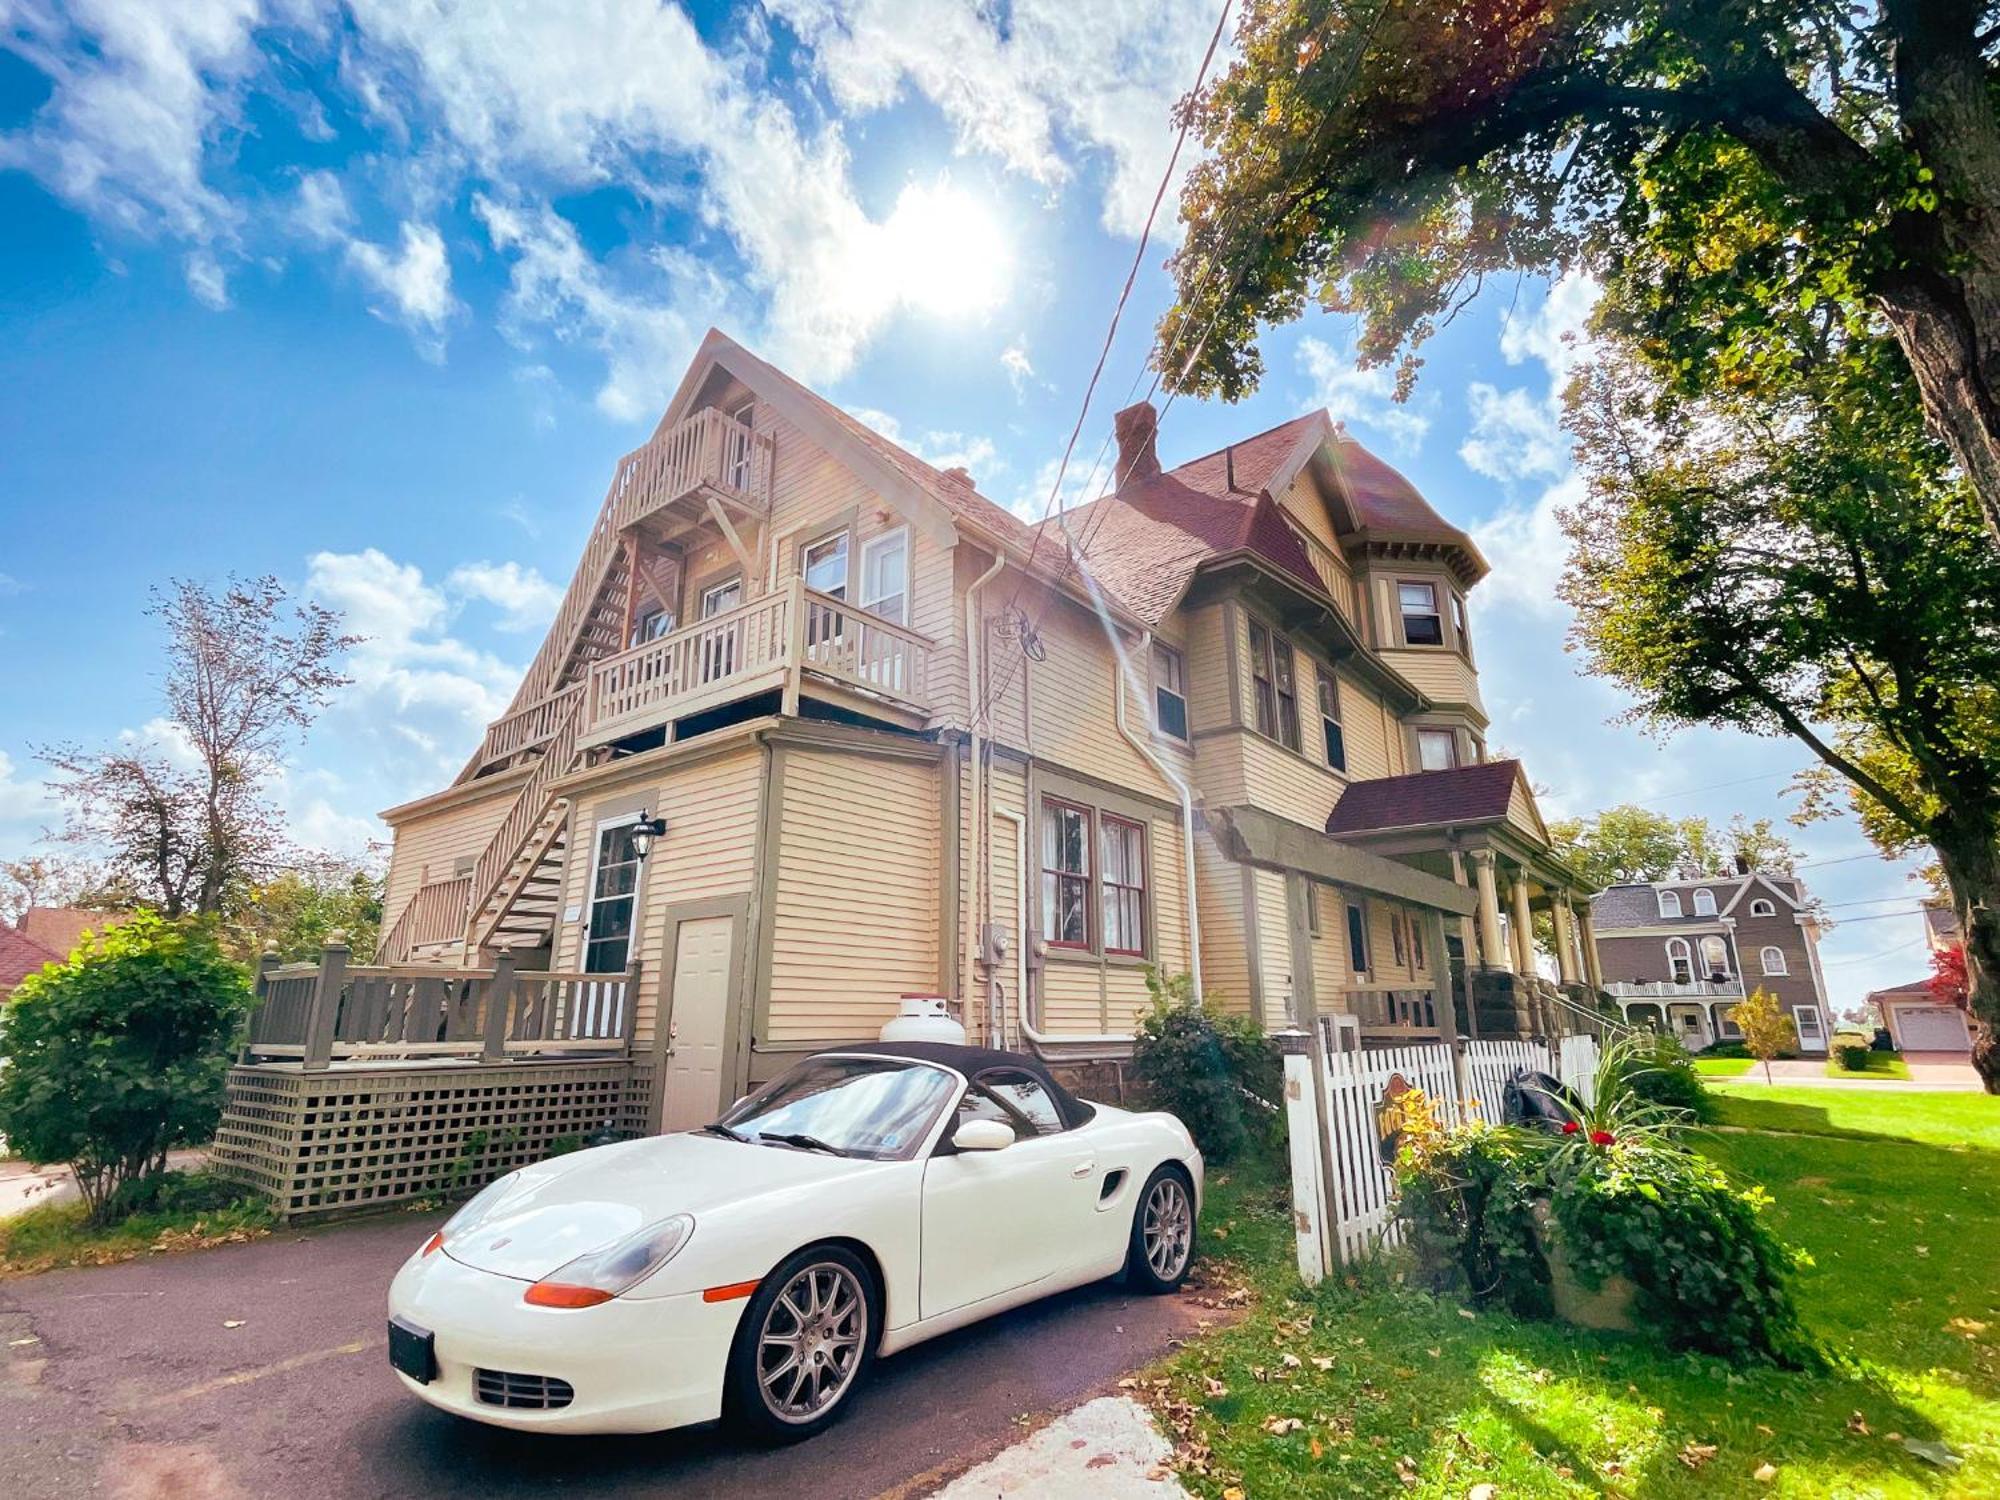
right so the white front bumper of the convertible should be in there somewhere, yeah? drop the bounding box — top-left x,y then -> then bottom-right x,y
388,1250 -> 744,1432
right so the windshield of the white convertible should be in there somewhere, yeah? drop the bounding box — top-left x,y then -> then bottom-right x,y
718,1058 -> 958,1162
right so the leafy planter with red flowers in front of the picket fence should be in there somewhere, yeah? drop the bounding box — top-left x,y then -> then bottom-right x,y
1398,1044 -> 1818,1366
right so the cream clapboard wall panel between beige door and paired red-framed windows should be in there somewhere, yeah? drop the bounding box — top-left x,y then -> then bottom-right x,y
758,750 -> 940,1044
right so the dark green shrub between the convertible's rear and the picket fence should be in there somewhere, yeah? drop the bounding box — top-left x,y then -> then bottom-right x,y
1132,968 -> 1284,1164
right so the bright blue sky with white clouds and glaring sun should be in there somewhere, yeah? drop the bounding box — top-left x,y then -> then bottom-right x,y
0,0 -> 1924,1006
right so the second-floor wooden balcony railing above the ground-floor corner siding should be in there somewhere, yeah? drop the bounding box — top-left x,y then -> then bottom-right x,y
584,578 -> 932,740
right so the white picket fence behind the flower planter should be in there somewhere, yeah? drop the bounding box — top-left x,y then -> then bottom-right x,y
1280,1026 -> 1598,1284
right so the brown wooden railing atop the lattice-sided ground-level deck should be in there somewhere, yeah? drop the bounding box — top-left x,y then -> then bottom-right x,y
244,944 -> 638,1072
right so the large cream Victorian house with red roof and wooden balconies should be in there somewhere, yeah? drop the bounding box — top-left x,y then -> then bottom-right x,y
224,334 -> 1596,1208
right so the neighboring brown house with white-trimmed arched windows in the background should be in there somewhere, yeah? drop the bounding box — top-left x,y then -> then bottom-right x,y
1590,870 -> 1832,1054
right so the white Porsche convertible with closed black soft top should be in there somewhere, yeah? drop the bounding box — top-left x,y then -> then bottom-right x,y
388,1042 -> 1202,1440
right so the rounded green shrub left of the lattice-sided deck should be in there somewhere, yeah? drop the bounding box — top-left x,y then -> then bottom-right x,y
0,912 -> 250,1224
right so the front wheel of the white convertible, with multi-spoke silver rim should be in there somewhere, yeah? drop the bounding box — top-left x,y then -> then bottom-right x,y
728,1244 -> 878,1442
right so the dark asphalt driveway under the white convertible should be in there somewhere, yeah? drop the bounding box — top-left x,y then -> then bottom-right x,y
0,1214 -> 1214,1500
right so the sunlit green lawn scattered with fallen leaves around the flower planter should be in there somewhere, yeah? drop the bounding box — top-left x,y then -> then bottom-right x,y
1152,1088 -> 2000,1500
